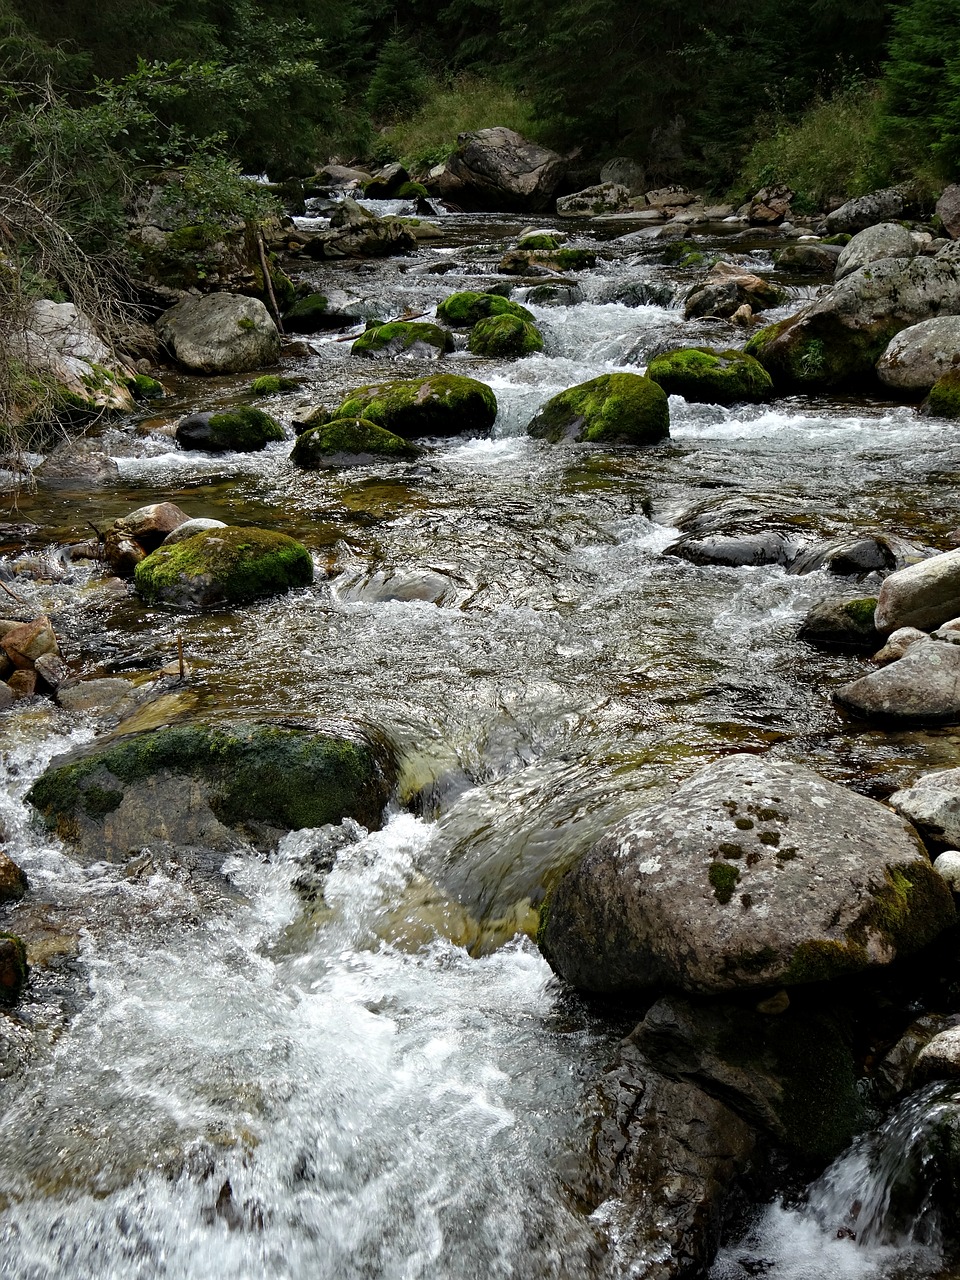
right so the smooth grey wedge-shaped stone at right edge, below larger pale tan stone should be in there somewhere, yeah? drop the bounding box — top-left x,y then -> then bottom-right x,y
833,640 -> 960,724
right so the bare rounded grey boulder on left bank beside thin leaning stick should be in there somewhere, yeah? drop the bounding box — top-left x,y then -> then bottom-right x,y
156,293 -> 280,374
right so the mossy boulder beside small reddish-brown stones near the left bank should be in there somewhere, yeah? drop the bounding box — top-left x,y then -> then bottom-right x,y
133,525 -> 314,608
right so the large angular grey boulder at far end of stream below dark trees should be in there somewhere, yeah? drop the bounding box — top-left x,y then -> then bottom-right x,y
438,127 -> 566,212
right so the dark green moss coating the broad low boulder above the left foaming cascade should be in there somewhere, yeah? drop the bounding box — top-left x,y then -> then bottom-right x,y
27,724 -> 393,831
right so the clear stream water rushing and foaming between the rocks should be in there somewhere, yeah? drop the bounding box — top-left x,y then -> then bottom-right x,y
0,204 -> 960,1280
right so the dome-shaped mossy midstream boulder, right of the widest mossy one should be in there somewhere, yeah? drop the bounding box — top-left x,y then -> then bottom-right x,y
527,374 -> 669,444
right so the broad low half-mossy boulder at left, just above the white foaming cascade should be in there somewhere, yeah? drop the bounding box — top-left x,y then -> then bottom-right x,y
27,723 -> 396,860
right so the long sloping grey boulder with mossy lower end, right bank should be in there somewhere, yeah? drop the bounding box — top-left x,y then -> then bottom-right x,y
746,257 -> 960,390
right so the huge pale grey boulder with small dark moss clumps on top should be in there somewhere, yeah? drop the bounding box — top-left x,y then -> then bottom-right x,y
538,752 -> 955,996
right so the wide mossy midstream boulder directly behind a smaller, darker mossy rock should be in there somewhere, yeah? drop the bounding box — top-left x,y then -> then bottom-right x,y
334,374 -> 497,440
